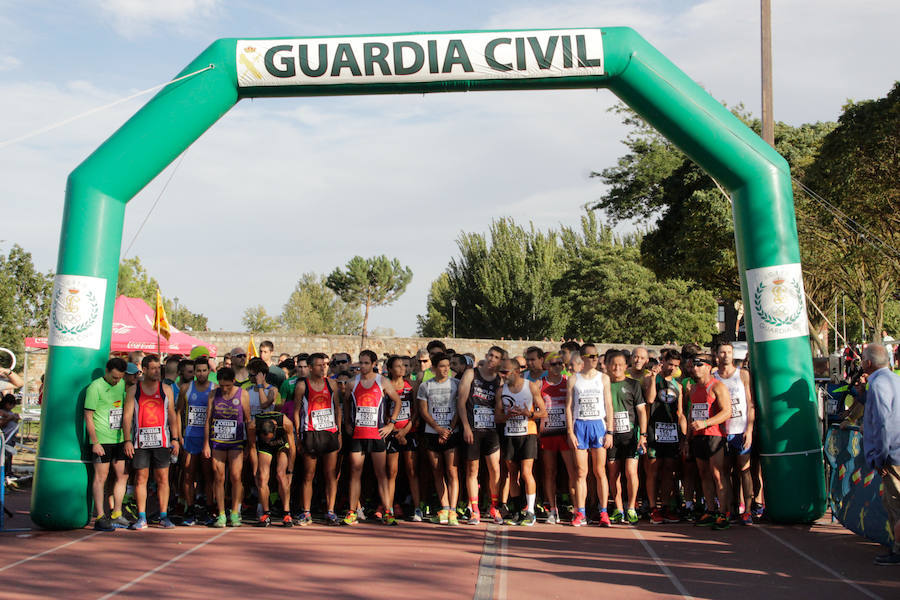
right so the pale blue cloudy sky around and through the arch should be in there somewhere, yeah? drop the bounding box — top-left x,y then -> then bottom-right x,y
0,0 -> 900,335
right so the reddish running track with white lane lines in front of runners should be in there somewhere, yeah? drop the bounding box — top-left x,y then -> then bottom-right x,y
0,493 -> 900,600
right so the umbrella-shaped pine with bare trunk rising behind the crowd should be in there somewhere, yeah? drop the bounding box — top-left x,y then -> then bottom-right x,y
325,255 -> 412,345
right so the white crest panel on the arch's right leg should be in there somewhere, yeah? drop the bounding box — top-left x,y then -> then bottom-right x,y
747,263 -> 809,342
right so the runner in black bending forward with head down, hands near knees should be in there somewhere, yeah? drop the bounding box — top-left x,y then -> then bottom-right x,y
250,411 -> 297,527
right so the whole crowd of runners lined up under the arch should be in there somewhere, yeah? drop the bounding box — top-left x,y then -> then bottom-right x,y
84,340 -> 763,530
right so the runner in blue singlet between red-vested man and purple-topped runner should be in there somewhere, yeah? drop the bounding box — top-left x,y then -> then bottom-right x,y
177,356 -> 215,527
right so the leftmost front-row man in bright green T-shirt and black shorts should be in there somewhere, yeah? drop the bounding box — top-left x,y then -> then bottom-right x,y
84,358 -> 130,531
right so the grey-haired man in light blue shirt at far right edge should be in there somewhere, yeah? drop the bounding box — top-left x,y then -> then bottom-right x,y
862,344 -> 900,565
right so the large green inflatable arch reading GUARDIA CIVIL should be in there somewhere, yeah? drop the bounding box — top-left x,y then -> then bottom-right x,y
31,27 -> 825,529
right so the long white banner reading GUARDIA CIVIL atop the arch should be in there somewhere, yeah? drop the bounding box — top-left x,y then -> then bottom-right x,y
237,29 -> 604,87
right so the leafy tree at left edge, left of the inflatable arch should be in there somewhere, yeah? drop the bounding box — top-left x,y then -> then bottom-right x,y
0,244 -> 53,365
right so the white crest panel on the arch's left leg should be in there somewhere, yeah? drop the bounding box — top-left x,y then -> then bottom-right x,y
48,275 -> 106,350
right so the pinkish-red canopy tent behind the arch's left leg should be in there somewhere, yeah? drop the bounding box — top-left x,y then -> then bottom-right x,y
25,296 -> 216,356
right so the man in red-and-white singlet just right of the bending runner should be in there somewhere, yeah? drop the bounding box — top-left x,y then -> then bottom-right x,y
294,352 -> 346,526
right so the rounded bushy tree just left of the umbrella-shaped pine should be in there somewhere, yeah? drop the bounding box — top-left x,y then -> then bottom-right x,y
280,273 -> 362,335
